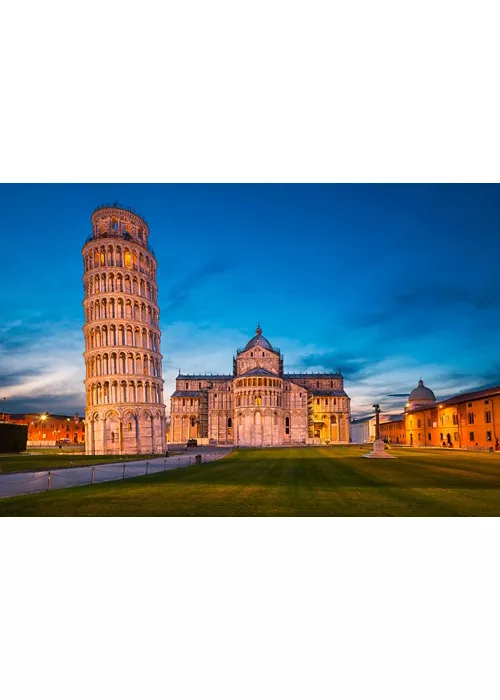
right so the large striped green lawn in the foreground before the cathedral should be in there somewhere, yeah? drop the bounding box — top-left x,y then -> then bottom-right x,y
0,446 -> 500,516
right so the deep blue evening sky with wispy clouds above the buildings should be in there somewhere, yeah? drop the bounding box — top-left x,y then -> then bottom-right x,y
0,184 -> 500,415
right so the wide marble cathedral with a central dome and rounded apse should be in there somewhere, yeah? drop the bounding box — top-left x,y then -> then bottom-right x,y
170,326 -> 351,446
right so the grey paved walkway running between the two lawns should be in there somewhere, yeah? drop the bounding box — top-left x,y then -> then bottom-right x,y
0,447 -> 231,497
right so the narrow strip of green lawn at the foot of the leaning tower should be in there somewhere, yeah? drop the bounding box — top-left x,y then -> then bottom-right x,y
0,452 -> 161,474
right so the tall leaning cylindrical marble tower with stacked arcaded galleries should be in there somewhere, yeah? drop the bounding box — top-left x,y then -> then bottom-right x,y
82,203 -> 166,454
